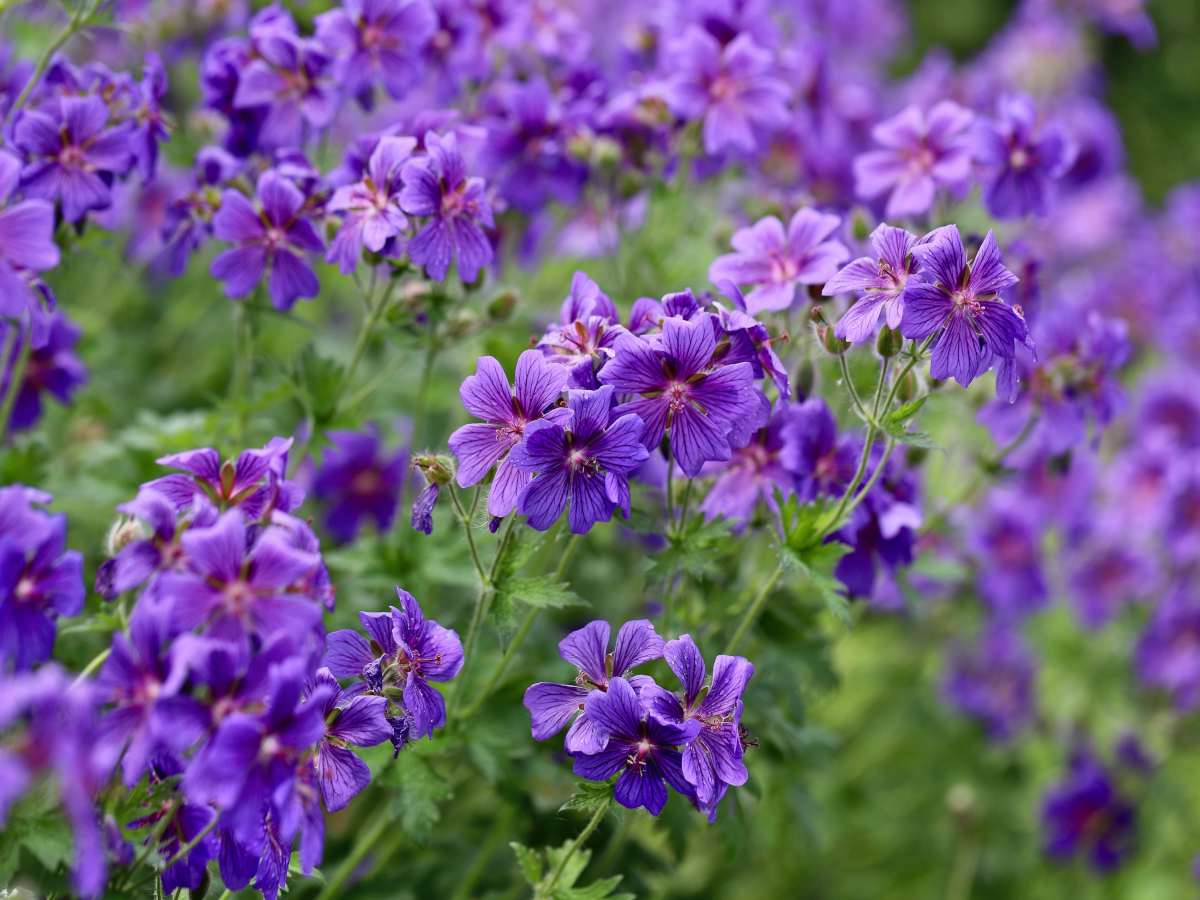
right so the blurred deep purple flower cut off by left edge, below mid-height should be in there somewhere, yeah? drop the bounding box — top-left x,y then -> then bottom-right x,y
0,485 -> 84,672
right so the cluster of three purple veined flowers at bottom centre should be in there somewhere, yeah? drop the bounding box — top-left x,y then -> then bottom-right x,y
524,619 -> 754,821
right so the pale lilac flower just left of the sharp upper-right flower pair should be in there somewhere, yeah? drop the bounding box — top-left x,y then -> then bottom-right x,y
708,208 -> 850,316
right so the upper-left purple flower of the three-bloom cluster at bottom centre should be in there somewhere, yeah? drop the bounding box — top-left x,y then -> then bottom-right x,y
523,619 -> 664,754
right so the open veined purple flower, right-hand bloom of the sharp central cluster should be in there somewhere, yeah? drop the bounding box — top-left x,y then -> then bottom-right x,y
599,314 -> 760,478
